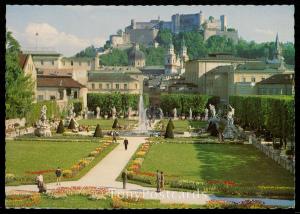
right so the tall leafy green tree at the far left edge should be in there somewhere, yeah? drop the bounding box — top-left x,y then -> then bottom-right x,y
5,31 -> 34,119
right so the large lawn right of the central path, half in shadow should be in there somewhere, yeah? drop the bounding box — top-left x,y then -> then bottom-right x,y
141,143 -> 294,187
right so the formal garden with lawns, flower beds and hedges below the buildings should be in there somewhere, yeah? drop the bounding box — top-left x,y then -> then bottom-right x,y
5,94 -> 295,209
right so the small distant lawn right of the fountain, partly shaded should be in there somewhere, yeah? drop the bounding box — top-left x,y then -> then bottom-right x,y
155,119 -> 207,132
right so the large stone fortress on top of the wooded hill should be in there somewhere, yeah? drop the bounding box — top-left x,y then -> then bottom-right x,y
110,11 -> 238,48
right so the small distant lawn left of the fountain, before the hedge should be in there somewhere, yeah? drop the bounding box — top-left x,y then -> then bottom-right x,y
77,119 -> 138,130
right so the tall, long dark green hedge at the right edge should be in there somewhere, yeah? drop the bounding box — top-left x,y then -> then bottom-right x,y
229,95 -> 295,140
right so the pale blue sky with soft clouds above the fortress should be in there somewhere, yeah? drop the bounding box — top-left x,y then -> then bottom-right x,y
6,5 -> 294,56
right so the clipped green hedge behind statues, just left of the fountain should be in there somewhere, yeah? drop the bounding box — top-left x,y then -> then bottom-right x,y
87,92 -> 149,116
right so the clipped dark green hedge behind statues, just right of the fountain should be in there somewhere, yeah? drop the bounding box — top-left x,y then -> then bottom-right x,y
160,93 -> 211,115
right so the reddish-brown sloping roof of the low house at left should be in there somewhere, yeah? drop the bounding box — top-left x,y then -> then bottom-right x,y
37,76 -> 85,88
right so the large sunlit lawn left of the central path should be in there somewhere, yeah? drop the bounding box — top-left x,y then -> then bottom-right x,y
5,141 -> 116,185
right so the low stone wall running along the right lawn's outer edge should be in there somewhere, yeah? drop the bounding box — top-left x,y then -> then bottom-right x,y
252,137 -> 295,174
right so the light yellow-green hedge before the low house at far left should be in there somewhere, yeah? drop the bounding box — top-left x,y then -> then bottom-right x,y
26,100 -> 61,125
